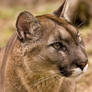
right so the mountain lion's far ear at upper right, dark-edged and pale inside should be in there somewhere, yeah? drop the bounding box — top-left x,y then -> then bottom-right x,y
53,0 -> 82,26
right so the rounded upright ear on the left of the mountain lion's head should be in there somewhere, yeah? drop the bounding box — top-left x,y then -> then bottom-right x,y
16,11 -> 40,41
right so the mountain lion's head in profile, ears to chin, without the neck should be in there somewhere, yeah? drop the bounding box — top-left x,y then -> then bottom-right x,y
16,2 -> 88,77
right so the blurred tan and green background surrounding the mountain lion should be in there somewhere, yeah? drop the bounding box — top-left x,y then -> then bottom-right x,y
0,0 -> 92,92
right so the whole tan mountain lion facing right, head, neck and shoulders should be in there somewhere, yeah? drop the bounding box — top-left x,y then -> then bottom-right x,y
0,0 -> 88,92
